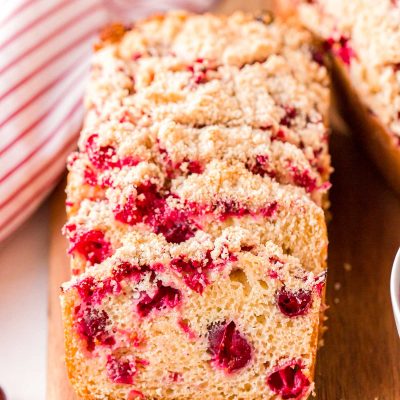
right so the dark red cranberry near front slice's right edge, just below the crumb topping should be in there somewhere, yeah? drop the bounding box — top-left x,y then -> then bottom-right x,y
276,287 -> 312,317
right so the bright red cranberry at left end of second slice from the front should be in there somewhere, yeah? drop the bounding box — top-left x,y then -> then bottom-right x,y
69,229 -> 112,265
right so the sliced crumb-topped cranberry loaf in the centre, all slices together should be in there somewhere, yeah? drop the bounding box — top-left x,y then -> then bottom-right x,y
61,12 -> 331,400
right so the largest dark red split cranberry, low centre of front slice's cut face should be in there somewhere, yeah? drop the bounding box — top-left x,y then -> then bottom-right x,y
208,321 -> 252,373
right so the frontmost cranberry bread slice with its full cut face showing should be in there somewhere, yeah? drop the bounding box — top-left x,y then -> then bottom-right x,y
62,227 -> 325,400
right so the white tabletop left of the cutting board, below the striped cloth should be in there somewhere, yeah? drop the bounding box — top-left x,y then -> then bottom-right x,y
0,203 -> 49,400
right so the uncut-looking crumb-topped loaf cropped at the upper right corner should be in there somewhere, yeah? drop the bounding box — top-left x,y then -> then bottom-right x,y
284,0 -> 400,193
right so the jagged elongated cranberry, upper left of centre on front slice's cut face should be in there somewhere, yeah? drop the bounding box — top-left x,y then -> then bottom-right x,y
137,283 -> 181,317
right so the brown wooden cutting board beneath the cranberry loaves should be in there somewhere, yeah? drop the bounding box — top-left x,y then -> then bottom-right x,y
47,0 -> 400,400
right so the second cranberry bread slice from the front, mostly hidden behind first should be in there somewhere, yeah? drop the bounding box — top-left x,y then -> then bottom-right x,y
65,160 -> 327,274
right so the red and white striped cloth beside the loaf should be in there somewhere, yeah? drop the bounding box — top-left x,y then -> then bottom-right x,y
0,0 -> 213,241
